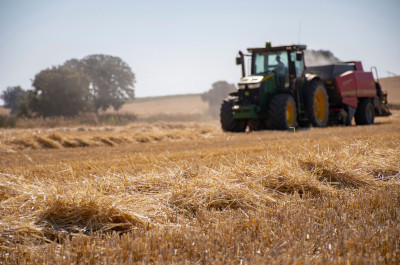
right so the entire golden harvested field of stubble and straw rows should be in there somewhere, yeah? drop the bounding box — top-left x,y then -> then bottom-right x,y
0,111 -> 400,264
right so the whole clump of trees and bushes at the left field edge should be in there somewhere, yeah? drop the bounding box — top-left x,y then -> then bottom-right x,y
1,54 -> 136,117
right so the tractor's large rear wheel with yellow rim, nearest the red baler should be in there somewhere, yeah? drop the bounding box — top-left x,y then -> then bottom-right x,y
304,79 -> 329,127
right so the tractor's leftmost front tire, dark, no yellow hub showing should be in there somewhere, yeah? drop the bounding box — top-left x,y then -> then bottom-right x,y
220,97 -> 247,132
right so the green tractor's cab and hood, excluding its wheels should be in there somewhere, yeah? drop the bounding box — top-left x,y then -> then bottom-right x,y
234,42 -> 306,119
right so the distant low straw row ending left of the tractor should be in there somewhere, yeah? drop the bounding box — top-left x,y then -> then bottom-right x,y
0,122 -> 219,150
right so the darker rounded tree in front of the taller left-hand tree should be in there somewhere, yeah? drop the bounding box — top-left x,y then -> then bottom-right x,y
27,66 -> 90,117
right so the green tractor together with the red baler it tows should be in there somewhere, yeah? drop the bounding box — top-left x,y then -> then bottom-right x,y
220,42 -> 390,132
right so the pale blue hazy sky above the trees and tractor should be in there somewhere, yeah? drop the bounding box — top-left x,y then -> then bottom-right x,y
0,0 -> 400,100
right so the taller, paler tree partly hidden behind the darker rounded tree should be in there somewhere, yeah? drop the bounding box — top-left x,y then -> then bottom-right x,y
64,54 -> 135,111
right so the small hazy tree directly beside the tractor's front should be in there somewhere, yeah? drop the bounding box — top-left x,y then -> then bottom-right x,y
201,81 -> 236,117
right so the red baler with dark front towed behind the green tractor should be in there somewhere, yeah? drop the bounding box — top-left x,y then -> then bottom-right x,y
306,61 -> 391,124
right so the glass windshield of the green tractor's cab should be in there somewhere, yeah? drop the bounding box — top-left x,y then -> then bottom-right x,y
252,51 -> 288,76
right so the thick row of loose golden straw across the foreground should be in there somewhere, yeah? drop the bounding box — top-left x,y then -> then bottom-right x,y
0,138 -> 400,244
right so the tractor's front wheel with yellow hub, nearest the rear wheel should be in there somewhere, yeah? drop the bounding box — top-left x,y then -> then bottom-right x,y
268,94 -> 297,130
